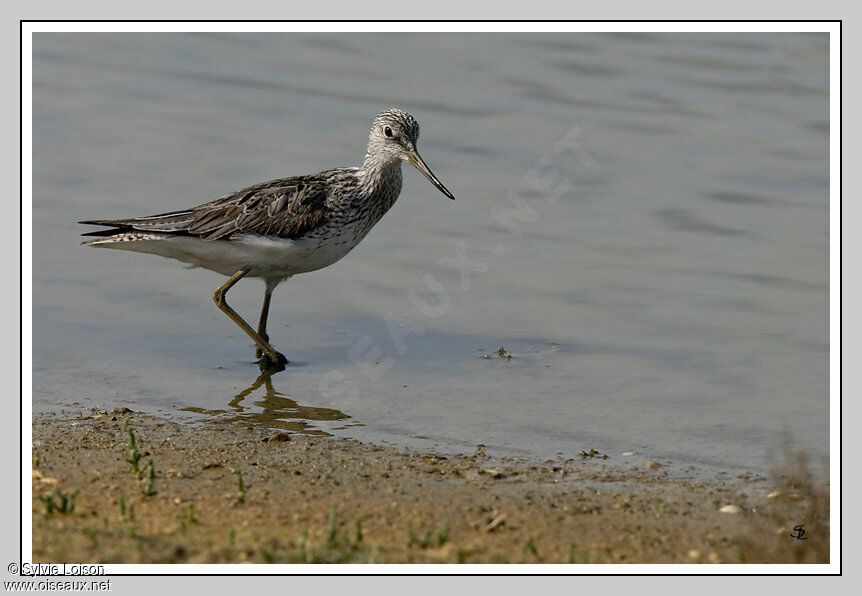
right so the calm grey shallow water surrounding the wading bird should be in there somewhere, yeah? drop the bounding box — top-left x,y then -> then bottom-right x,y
33,33 -> 829,474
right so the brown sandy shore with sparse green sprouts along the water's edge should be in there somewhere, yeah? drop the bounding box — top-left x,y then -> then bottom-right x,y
33,410 -> 829,564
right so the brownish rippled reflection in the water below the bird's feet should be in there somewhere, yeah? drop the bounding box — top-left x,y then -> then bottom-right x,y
181,368 -> 350,436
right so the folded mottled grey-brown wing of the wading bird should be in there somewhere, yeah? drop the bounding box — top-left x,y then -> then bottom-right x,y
80,178 -> 327,240
